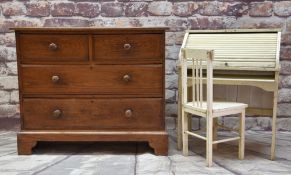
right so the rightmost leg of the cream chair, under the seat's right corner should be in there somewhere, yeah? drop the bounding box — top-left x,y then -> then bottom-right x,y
238,110 -> 245,160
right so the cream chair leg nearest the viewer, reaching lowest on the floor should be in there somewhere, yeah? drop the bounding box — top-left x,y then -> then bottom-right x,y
206,115 -> 213,167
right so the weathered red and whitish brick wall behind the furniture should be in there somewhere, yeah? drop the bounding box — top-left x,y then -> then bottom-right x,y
0,0 -> 291,130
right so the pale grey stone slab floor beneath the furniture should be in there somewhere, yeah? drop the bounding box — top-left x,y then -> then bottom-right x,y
0,130 -> 291,175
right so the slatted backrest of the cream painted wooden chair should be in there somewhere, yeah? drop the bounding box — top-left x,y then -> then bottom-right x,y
181,48 -> 214,112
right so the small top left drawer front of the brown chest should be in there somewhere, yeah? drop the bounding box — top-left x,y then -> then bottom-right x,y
19,34 -> 89,63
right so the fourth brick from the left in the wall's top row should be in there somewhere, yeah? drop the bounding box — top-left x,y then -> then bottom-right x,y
76,2 -> 100,18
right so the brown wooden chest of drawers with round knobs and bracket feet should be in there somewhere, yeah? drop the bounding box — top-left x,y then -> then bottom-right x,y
14,28 -> 168,155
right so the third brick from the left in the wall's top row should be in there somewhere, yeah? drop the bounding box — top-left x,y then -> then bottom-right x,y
51,2 -> 75,16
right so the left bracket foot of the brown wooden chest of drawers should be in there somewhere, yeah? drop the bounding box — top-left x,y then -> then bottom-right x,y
17,136 -> 37,155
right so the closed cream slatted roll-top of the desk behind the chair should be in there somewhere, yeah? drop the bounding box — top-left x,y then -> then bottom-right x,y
183,29 -> 281,70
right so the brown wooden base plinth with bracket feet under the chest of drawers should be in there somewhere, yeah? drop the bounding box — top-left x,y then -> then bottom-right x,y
17,130 -> 168,156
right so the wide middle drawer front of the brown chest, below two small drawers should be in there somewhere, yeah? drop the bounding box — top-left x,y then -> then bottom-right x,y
21,65 -> 164,97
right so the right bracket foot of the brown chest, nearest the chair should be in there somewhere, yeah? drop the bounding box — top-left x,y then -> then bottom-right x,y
149,136 -> 168,156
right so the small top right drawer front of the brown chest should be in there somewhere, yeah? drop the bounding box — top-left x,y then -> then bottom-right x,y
93,34 -> 165,64
